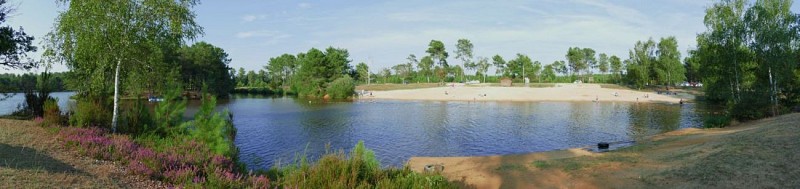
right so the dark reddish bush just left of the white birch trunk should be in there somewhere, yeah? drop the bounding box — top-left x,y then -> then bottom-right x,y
69,97 -> 113,128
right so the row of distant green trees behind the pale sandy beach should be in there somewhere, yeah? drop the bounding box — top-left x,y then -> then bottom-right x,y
362,36 -> 680,88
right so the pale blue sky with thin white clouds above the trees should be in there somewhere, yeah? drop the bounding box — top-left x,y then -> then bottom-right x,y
0,0 -> 800,73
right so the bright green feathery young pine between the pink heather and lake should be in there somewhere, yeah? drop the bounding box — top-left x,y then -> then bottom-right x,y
181,95 -> 238,157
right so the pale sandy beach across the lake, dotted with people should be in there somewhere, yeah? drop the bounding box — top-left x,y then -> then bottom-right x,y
360,84 -> 693,103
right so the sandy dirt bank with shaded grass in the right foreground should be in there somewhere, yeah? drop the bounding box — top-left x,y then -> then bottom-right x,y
409,113 -> 800,188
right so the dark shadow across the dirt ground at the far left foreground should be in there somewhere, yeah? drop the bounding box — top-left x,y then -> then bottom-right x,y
0,144 -> 86,174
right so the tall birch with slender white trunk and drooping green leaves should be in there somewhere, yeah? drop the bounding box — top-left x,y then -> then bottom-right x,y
49,0 -> 202,131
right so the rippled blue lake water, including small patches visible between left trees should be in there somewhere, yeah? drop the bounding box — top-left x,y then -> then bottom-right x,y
0,93 -> 705,168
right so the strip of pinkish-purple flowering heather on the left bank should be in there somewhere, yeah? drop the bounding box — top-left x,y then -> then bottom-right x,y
58,127 -> 270,188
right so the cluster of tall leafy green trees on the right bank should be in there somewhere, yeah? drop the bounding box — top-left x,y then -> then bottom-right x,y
686,0 -> 800,120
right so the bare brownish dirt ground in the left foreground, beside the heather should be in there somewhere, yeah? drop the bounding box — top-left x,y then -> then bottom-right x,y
0,119 -> 163,188
